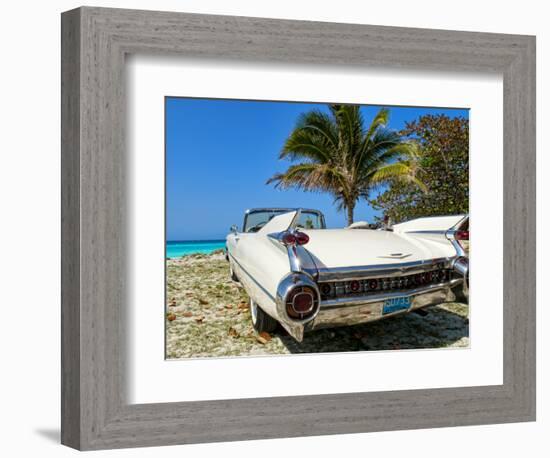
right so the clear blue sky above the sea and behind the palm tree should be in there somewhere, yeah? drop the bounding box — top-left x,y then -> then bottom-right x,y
165,97 -> 468,240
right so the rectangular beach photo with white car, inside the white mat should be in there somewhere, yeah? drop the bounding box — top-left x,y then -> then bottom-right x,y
164,96 -> 470,359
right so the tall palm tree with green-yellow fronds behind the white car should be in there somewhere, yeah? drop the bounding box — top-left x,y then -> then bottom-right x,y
267,105 -> 423,225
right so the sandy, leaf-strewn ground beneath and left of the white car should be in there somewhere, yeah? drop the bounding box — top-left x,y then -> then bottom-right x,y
166,251 -> 469,359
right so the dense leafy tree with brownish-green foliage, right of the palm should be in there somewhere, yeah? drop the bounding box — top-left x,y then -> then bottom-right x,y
369,114 -> 469,223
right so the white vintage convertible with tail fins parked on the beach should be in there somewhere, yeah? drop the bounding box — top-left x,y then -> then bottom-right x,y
227,208 -> 469,342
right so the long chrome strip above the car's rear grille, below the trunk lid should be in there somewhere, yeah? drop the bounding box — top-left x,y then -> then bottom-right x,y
318,257 -> 454,283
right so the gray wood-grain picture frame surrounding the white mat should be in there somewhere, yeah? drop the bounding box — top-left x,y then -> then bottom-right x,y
61,7 -> 536,450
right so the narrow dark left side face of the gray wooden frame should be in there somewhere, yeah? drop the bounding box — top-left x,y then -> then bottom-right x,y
61,11 -> 81,448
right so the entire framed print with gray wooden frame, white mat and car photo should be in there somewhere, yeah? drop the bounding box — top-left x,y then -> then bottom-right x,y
62,7 -> 535,450
